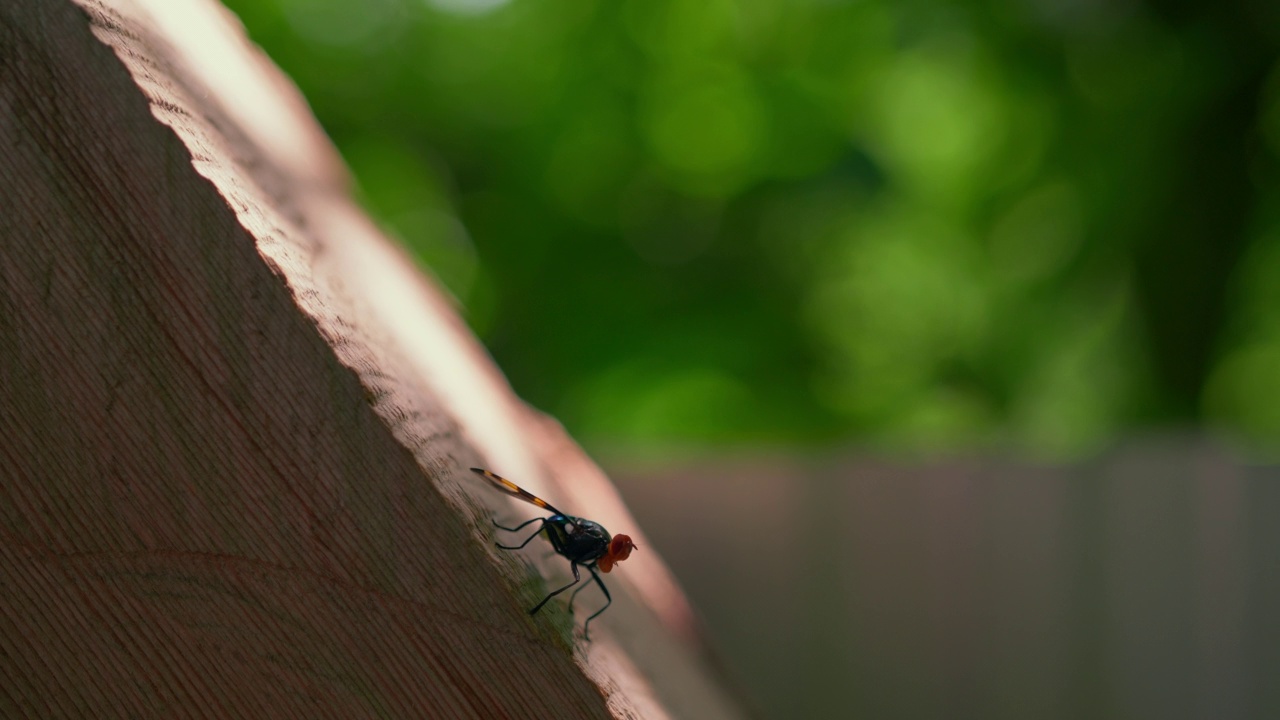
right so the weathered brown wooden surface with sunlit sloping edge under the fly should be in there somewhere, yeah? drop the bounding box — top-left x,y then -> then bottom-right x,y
0,0 -> 739,719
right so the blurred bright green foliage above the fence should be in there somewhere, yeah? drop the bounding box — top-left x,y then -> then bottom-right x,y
227,0 -> 1280,457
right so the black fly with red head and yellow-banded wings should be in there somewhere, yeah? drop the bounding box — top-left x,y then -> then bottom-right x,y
471,468 -> 636,639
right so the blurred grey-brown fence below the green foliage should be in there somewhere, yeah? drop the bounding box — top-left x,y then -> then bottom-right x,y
620,439 -> 1280,720
